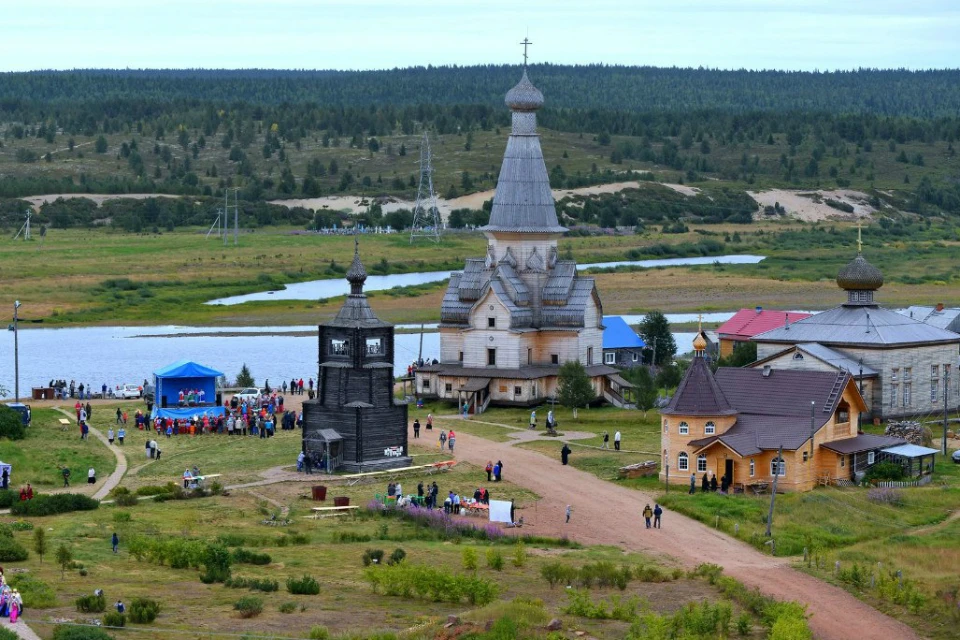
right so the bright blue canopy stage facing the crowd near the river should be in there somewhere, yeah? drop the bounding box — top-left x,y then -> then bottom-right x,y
151,360 -> 224,419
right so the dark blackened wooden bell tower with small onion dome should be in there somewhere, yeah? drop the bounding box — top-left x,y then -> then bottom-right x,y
303,245 -> 411,472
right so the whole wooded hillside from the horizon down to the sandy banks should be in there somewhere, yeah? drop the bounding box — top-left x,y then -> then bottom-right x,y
0,65 -> 960,228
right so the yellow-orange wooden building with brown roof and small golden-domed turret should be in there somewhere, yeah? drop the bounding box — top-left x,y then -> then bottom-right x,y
660,333 -> 903,491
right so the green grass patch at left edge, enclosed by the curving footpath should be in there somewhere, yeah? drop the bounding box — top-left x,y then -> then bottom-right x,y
0,409 -> 116,490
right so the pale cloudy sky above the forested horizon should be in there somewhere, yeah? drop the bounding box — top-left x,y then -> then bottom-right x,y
0,0 -> 960,71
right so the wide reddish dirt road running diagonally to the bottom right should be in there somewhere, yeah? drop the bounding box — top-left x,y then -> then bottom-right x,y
449,420 -> 919,640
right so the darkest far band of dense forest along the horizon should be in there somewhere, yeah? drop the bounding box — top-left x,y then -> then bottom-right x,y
0,64 -> 960,120
